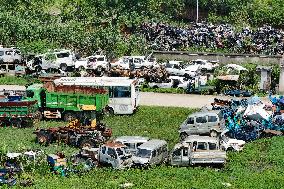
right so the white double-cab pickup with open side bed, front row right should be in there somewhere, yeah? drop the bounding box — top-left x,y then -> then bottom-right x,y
170,135 -> 226,166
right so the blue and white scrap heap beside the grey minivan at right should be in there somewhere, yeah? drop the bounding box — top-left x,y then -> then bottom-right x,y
212,97 -> 284,141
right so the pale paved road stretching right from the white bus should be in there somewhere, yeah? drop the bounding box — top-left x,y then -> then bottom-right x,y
140,92 -> 268,108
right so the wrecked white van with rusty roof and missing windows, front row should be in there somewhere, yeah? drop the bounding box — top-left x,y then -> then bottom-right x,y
98,142 -> 133,169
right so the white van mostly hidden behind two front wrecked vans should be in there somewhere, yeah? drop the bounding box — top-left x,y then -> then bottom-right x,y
114,136 -> 150,155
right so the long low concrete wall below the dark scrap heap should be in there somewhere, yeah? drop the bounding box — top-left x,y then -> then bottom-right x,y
153,51 -> 282,65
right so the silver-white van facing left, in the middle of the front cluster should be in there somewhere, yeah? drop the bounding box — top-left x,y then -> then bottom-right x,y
133,139 -> 168,167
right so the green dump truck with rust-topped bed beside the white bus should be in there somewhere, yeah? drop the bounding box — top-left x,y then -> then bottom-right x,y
26,84 -> 109,121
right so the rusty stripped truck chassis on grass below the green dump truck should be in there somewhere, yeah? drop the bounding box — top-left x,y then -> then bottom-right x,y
34,119 -> 112,147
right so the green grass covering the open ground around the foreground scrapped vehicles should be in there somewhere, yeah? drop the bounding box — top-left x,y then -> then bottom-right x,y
0,106 -> 284,189
